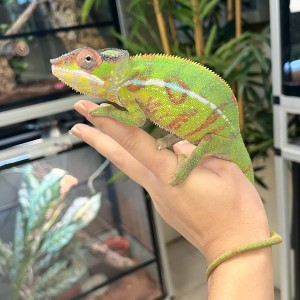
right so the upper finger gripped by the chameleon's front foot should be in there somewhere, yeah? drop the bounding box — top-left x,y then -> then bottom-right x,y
74,100 -> 177,182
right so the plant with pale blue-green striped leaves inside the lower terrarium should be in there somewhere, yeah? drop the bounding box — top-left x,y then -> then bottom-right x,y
0,166 -> 100,300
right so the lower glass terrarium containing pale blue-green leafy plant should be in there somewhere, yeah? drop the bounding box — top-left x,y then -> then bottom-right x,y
0,110 -> 167,300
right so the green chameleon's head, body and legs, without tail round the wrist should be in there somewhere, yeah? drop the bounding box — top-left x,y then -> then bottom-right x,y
51,48 -> 254,185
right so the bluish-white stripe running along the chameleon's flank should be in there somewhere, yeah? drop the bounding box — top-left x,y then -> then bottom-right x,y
123,78 -> 232,126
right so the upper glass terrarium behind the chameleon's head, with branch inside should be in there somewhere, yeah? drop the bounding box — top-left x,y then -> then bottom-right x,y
0,0 -> 119,111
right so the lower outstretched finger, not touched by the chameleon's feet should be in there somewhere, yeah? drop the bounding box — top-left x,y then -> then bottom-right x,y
71,124 -> 153,189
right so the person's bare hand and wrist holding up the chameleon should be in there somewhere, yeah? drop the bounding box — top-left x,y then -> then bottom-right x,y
71,100 -> 273,300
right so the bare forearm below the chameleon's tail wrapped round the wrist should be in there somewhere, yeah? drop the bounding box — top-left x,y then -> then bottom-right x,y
208,247 -> 274,300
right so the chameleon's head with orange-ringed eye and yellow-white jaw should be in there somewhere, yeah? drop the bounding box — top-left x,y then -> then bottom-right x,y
50,48 -> 129,97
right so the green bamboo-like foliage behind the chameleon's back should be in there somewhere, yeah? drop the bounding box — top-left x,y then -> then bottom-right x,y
118,0 -> 273,186
